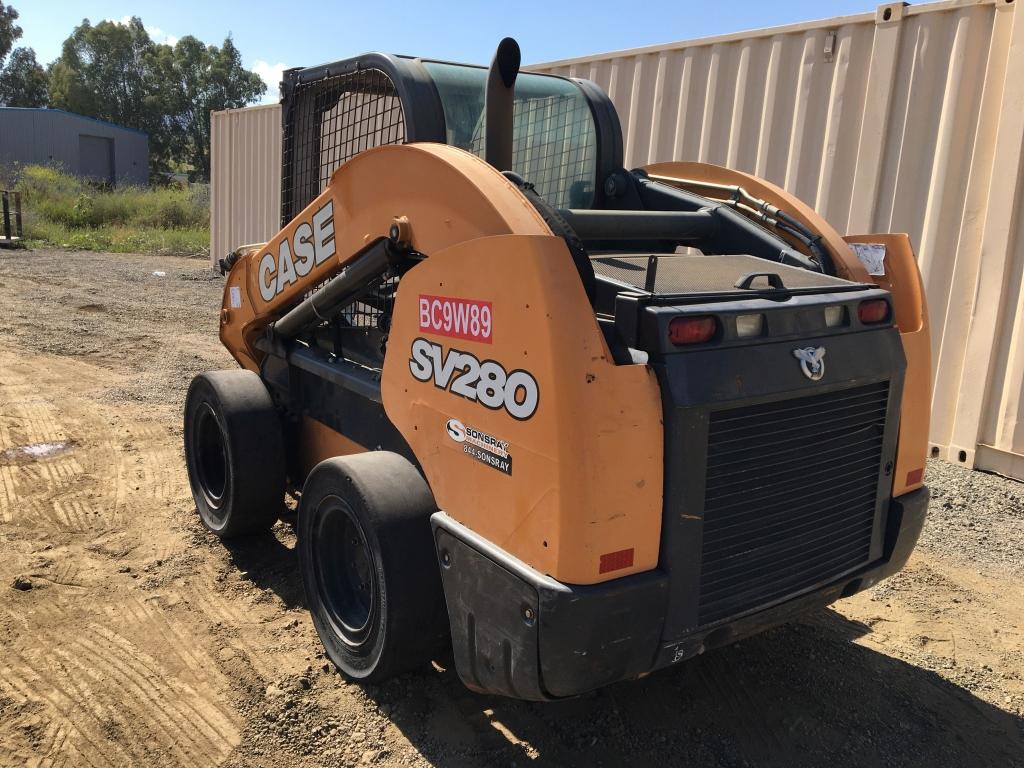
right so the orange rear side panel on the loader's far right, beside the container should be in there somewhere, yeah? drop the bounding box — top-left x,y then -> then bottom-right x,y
846,234 -> 932,496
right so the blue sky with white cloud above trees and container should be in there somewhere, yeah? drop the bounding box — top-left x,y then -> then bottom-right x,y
18,0 -> 877,102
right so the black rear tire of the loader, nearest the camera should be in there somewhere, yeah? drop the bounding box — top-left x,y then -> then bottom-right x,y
297,451 -> 449,683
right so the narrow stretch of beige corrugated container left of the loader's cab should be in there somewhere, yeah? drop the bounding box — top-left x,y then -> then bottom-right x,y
210,104 -> 281,262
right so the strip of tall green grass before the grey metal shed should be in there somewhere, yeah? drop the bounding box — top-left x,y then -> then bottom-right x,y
14,166 -> 210,256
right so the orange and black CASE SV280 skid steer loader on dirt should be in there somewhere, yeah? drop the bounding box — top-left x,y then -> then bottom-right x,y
184,39 -> 930,699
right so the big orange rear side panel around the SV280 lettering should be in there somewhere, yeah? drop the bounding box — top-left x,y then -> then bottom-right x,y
382,236 -> 664,584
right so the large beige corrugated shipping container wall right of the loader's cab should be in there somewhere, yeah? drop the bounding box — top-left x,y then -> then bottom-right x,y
214,0 -> 1024,478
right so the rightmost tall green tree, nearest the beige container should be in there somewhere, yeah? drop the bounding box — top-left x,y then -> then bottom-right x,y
152,36 -> 266,178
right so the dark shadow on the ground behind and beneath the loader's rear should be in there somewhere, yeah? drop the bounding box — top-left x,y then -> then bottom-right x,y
368,609 -> 1024,768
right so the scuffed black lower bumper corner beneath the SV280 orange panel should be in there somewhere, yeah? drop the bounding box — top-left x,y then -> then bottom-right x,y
431,512 -> 668,700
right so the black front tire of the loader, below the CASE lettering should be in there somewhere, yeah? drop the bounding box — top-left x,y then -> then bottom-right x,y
184,370 -> 285,539
